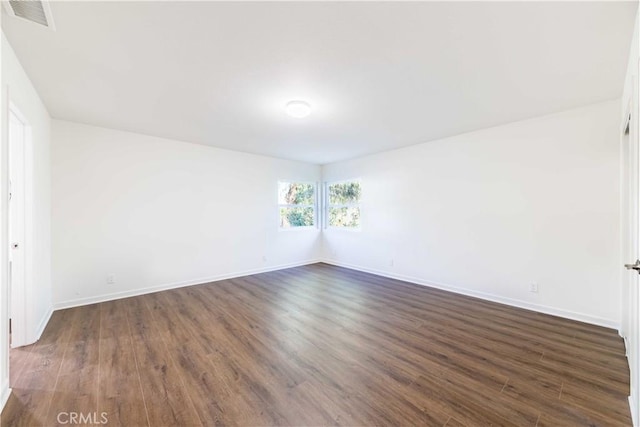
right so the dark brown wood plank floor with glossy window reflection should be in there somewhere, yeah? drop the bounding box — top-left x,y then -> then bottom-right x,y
2,264 -> 631,427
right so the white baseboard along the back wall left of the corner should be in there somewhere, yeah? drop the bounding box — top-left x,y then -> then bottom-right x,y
54,259 -> 322,310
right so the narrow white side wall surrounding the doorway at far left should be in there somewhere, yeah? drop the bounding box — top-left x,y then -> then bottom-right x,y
0,34 -> 52,403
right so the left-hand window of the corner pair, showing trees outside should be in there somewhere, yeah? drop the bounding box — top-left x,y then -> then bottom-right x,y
278,181 -> 316,229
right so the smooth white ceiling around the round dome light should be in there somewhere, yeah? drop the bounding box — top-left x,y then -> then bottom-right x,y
2,1 -> 637,164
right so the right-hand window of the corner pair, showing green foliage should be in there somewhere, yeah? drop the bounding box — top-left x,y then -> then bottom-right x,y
327,181 -> 362,229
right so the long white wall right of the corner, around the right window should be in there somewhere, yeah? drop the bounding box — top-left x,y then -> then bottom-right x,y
323,101 -> 620,326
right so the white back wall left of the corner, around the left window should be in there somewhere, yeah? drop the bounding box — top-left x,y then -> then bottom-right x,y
52,120 -> 321,307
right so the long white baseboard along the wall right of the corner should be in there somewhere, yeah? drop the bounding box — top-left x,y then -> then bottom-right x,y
322,259 -> 620,330
